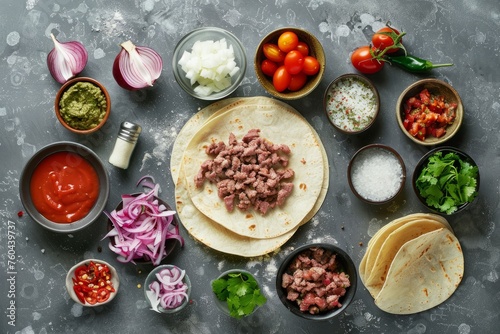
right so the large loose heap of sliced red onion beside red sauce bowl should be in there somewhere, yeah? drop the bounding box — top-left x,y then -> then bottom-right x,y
103,176 -> 184,266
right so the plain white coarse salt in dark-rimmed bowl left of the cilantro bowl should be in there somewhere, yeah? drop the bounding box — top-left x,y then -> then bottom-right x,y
351,148 -> 403,202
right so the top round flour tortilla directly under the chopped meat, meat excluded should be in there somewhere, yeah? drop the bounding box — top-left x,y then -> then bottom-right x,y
182,105 -> 325,239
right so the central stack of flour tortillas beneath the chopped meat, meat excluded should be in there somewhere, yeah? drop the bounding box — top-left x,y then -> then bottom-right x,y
170,97 -> 329,257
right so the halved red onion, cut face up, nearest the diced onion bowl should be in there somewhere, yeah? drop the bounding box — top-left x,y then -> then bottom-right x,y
113,41 -> 163,90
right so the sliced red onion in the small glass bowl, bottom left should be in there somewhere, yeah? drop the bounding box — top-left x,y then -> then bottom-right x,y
146,267 -> 188,312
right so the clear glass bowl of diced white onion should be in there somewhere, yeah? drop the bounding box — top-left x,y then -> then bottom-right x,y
172,27 -> 247,100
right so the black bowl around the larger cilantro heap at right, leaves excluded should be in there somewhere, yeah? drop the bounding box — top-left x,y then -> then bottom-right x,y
412,146 -> 480,215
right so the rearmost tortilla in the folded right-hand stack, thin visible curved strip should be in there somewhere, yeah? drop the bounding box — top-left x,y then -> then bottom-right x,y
359,213 -> 453,285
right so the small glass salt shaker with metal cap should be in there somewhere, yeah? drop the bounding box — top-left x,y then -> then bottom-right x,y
109,121 -> 142,169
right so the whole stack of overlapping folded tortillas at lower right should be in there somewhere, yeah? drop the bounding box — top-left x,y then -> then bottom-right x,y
359,213 -> 464,314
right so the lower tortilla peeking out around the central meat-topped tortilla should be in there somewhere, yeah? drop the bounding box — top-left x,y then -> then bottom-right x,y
171,97 -> 329,257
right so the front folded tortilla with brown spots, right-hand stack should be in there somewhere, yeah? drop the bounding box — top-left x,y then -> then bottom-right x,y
375,228 -> 464,314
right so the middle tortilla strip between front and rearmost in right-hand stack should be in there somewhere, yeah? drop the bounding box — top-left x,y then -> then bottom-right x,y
364,219 -> 454,298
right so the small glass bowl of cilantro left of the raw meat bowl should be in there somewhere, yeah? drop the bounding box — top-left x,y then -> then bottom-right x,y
211,269 -> 267,319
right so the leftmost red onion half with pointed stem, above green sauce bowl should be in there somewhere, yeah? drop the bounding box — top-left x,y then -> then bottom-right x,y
47,34 -> 88,84
